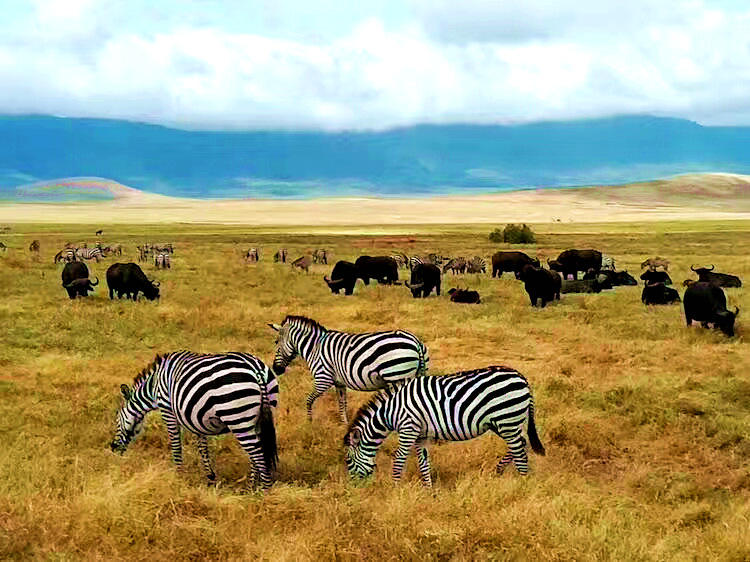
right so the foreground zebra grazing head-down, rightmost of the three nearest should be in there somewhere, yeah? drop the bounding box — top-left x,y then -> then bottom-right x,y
344,366 -> 545,487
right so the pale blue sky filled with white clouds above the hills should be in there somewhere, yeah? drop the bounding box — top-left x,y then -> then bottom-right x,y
0,0 -> 750,130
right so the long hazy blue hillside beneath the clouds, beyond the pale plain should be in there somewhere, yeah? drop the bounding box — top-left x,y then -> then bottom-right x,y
0,116 -> 750,200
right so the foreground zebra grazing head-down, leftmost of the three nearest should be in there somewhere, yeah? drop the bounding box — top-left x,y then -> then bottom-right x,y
110,351 -> 279,490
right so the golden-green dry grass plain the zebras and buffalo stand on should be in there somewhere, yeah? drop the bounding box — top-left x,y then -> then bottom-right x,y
0,221 -> 750,560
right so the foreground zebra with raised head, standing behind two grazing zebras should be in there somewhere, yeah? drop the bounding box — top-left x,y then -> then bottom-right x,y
269,316 -> 429,423
